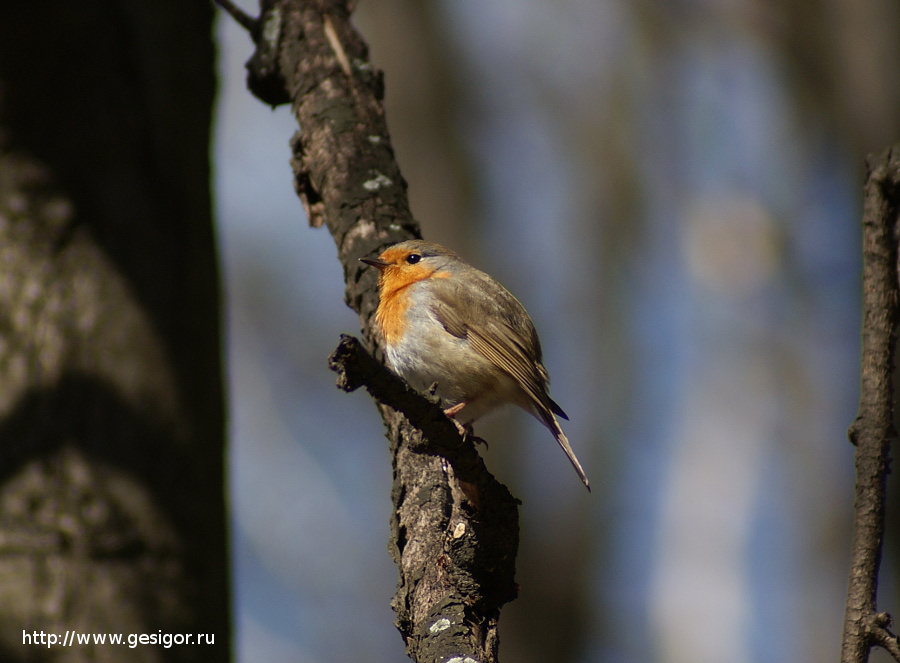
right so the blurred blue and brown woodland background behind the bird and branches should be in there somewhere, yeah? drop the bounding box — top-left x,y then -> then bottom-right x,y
215,0 -> 900,663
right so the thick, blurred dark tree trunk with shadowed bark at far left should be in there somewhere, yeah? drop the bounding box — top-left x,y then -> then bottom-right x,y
0,0 -> 230,661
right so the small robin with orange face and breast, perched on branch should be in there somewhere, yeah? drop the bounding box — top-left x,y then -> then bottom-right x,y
360,240 -> 591,491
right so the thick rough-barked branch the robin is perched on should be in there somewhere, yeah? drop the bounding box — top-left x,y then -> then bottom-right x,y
217,0 -> 518,663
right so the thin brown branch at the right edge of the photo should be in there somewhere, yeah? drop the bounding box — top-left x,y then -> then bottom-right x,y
841,148 -> 900,663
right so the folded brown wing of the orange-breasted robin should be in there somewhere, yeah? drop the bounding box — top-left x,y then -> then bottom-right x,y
431,270 -> 568,419
